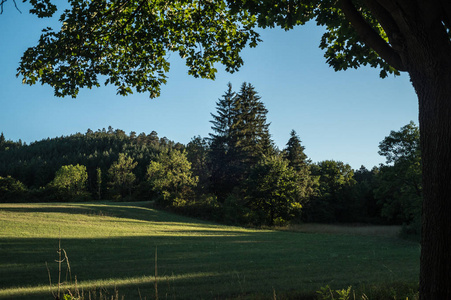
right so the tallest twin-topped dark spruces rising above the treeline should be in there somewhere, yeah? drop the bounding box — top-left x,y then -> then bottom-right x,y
210,83 -> 274,201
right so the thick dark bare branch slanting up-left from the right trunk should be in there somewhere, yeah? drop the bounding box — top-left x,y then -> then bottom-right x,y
340,0 -> 407,71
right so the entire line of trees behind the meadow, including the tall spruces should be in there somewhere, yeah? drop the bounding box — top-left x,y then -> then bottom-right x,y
0,83 -> 421,232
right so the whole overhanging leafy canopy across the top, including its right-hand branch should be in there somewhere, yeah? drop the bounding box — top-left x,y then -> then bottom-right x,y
12,0 -> 438,97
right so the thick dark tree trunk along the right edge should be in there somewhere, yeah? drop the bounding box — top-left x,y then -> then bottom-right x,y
409,40 -> 451,300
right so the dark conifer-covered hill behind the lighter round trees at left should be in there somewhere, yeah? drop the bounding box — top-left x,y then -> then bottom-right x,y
0,127 -> 183,198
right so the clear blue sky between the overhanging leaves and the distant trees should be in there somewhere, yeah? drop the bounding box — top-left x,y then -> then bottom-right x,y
0,1 -> 418,168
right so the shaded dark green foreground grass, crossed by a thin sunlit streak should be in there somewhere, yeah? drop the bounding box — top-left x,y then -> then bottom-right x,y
0,231 -> 419,299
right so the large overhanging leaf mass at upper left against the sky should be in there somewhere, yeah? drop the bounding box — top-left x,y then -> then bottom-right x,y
18,0 -> 258,98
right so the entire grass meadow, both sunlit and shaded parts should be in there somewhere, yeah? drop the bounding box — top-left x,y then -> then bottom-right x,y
0,202 -> 420,300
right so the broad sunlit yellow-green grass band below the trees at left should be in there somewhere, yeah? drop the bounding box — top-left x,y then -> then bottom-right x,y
0,204 -> 255,238
